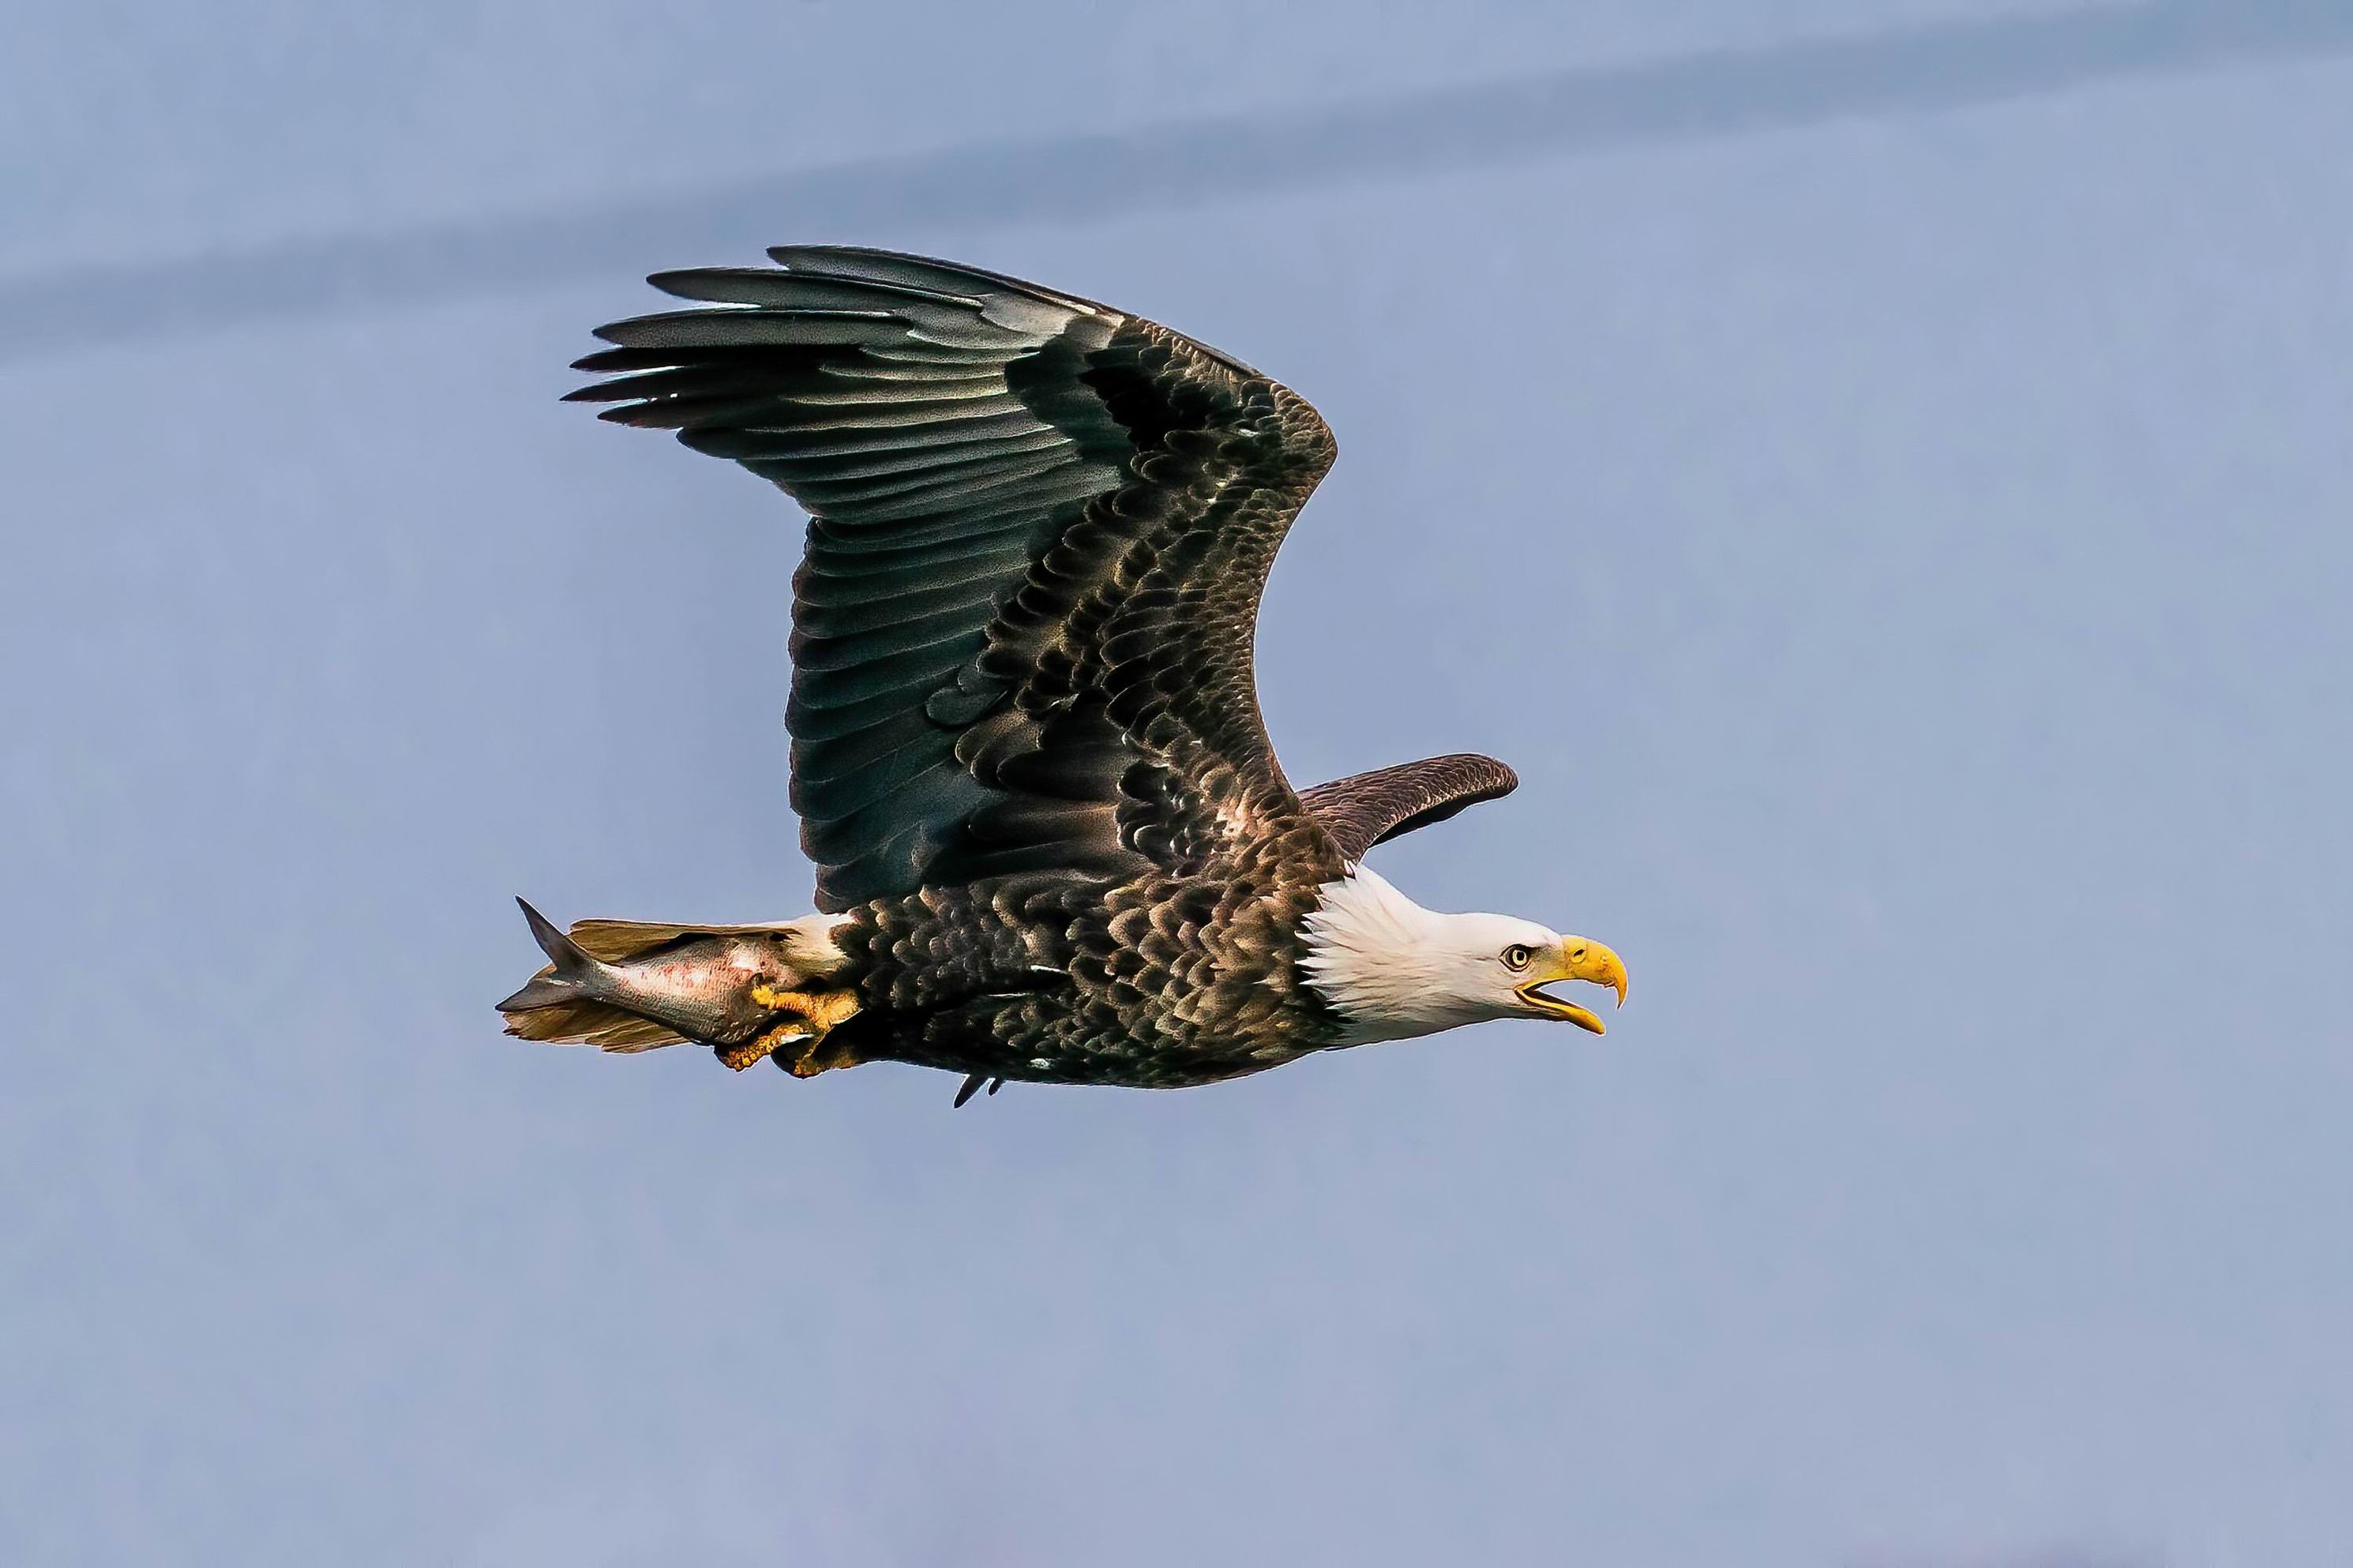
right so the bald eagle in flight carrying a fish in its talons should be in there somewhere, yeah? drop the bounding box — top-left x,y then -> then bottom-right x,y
501,245 -> 1626,1105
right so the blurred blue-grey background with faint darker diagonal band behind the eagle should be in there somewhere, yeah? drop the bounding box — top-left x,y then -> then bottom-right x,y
0,0 -> 2353,1568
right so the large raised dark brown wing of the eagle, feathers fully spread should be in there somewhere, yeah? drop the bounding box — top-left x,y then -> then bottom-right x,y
572,247 -> 1334,911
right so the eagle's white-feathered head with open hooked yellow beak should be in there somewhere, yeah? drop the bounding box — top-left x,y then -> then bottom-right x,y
1299,866 -> 1626,1045
